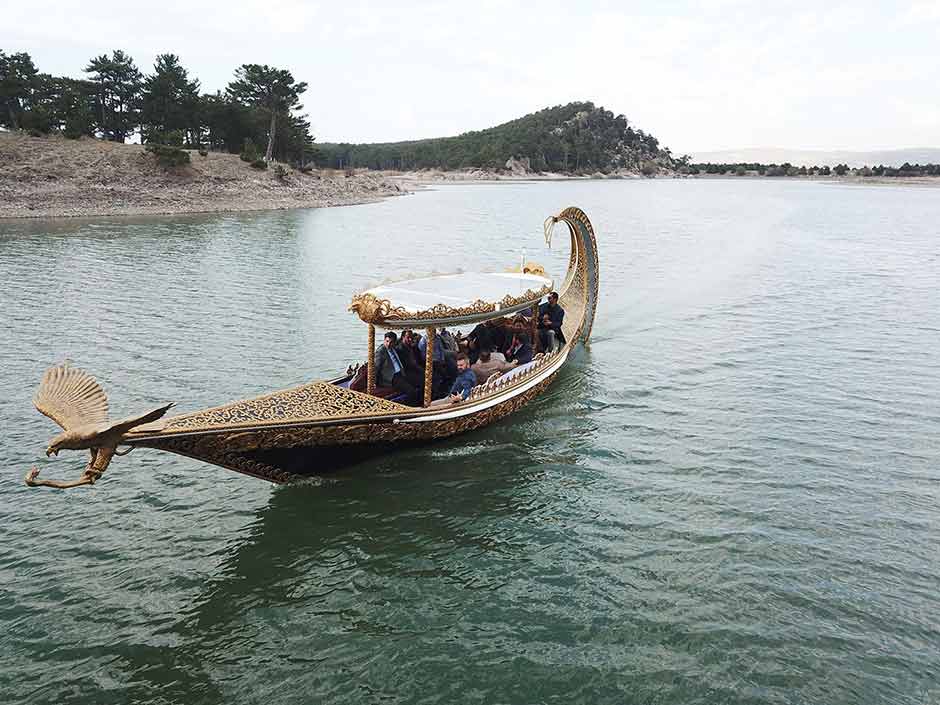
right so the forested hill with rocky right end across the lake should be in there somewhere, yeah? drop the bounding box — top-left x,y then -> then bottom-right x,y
319,102 -> 677,173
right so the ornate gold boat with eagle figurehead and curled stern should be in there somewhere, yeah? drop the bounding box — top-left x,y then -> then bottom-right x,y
26,207 -> 598,488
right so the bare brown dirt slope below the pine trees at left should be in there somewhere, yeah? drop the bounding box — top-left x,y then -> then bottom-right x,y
0,132 -> 402,218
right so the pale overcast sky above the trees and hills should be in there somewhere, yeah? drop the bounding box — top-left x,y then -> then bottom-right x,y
0,0 -> 940,153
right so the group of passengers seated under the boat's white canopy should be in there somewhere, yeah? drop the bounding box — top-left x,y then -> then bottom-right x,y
375,292 -> 565,406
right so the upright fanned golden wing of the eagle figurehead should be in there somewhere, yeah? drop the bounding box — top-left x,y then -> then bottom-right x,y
33,364 -> 108,431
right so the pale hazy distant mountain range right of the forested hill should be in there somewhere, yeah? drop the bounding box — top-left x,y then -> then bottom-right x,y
690,147 -> 940,167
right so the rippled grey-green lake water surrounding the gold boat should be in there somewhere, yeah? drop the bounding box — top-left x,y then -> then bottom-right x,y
0,180 -> 940,705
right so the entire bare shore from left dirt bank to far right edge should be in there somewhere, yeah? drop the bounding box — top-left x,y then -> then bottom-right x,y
7,132 -> 940,222
